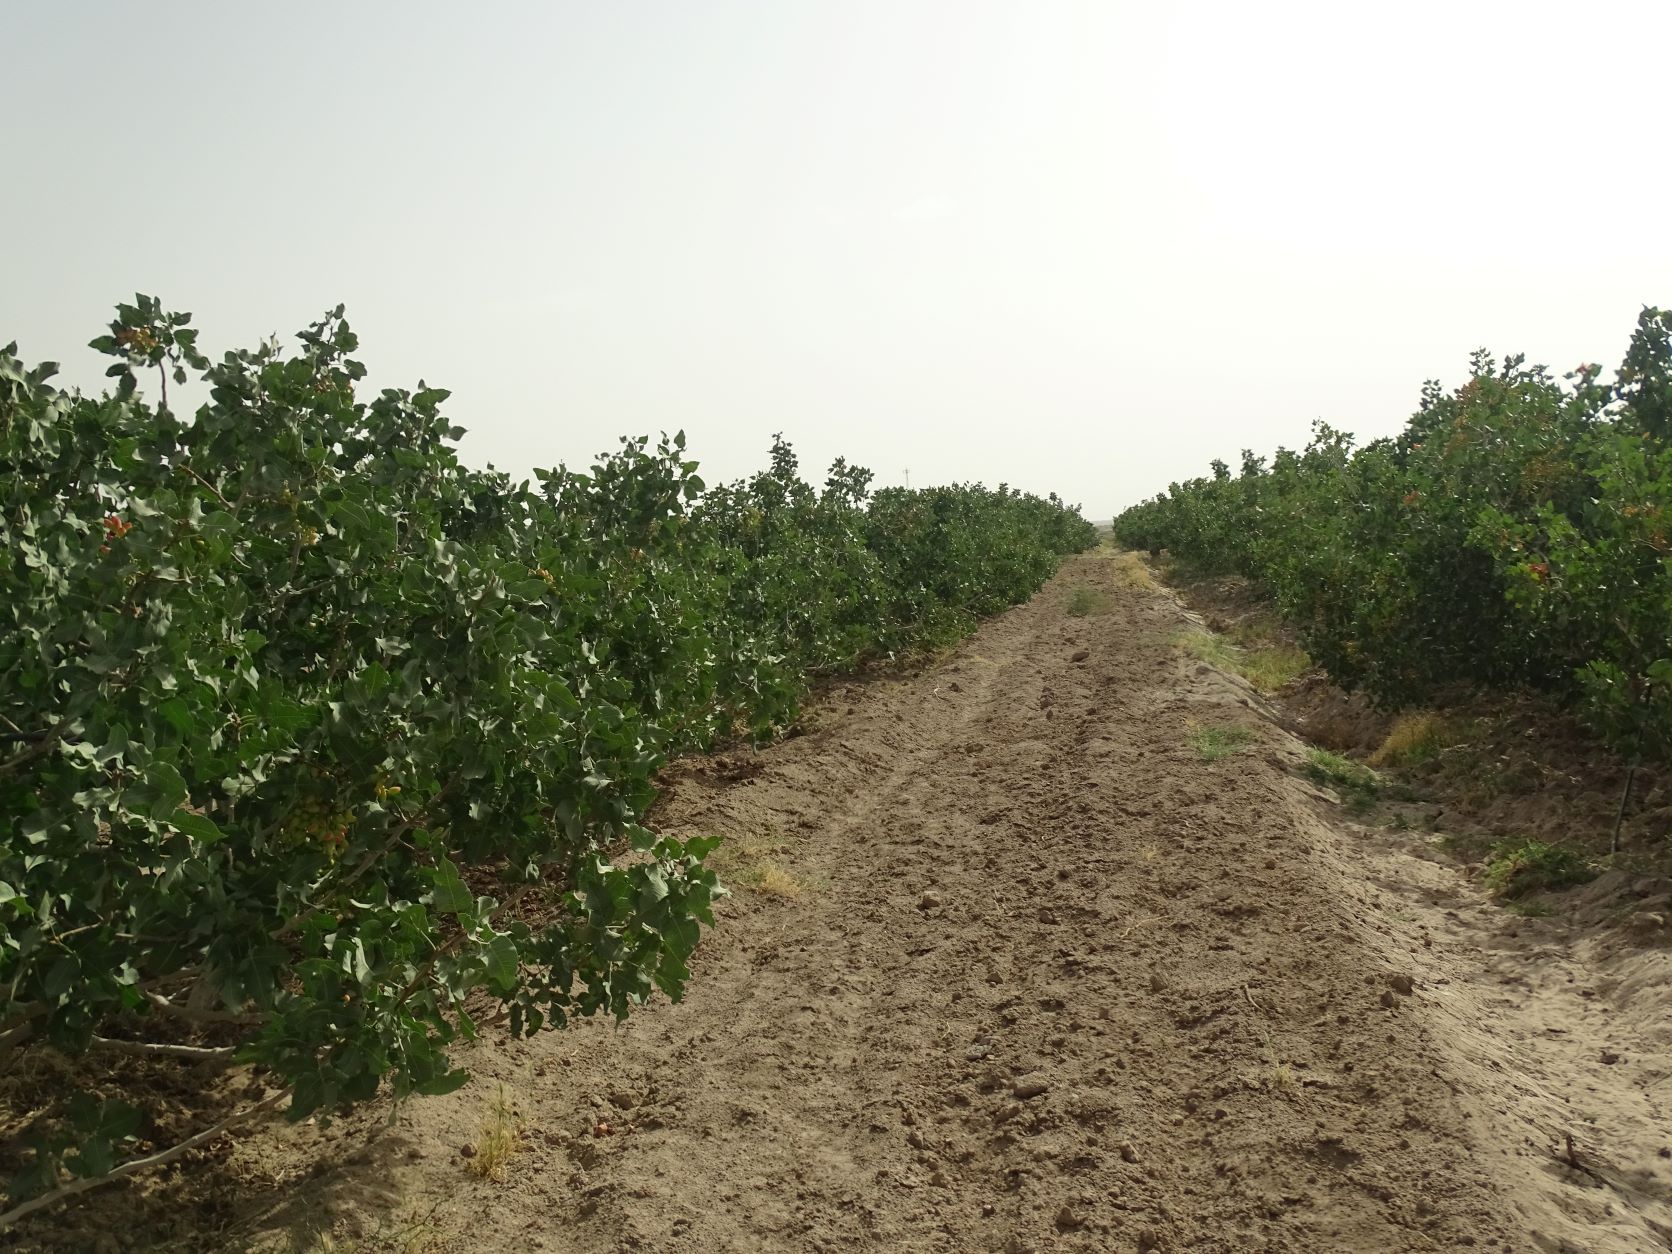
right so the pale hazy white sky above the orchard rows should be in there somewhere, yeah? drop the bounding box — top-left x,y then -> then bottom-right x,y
0,0 -> 1672,517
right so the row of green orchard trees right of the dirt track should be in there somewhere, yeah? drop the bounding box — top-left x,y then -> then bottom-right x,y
1115,309 -> 1672,761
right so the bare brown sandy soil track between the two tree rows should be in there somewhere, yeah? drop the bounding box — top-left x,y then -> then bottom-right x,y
13,557 -> 1672,1254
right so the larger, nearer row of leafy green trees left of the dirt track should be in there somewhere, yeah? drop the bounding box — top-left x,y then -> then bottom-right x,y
0,298 -> 1095,1200
